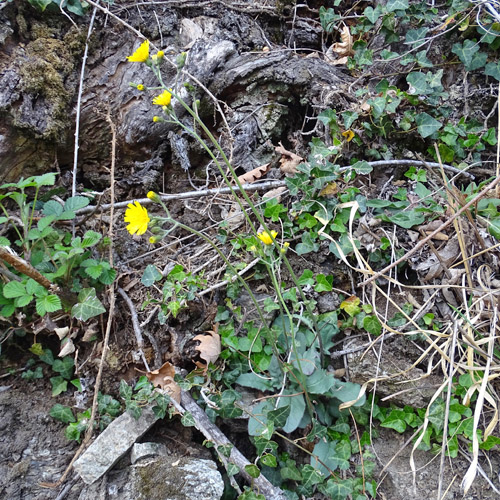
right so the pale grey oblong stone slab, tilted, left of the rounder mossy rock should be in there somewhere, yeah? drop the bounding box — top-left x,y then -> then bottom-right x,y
73,408 -> 158,484
